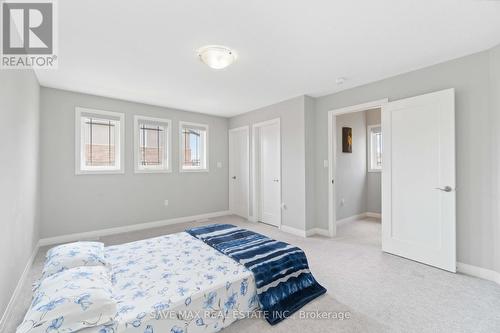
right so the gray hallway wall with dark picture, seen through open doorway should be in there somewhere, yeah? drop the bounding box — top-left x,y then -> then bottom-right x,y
336,112 -> 367,220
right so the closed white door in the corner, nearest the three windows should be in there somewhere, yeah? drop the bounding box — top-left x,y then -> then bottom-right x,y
229,127 -> 249,218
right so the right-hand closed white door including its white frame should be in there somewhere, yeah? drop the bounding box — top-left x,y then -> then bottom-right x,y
252,118 -> 281,227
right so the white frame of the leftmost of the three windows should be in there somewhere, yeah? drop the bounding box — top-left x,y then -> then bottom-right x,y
75,107 -> 125,175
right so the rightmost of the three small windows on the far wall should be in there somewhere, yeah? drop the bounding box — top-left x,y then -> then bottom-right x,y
179,121 -> 208,171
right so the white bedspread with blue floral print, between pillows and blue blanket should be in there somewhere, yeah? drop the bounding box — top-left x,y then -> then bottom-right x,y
84,232 -> 258,333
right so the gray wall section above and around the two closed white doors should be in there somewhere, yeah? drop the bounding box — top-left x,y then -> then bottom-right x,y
229,96 -> 311,230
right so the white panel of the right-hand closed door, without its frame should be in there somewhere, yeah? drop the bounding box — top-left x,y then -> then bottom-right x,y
259,122 -> 281,226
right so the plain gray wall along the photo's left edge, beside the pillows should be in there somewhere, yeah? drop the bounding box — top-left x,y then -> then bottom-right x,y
0,70 -> 40,315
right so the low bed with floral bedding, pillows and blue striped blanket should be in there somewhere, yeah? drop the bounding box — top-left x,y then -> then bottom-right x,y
17,224 -> 326,333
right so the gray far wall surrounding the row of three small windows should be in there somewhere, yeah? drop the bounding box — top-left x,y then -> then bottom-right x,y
40,88 -> 228,238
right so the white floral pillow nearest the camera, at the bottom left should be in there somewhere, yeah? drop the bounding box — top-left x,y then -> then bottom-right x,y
16,266 -> 117,333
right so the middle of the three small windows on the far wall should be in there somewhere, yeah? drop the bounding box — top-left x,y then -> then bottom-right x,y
134,116 -> 172,173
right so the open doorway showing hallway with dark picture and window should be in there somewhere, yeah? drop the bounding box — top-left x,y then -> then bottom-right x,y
333,108 -> 382,249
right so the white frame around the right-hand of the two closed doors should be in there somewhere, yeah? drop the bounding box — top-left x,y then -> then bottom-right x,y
251,118 -> 283,229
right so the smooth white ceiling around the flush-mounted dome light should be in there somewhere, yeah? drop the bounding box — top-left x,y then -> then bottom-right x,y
37,0 -> 500,116
